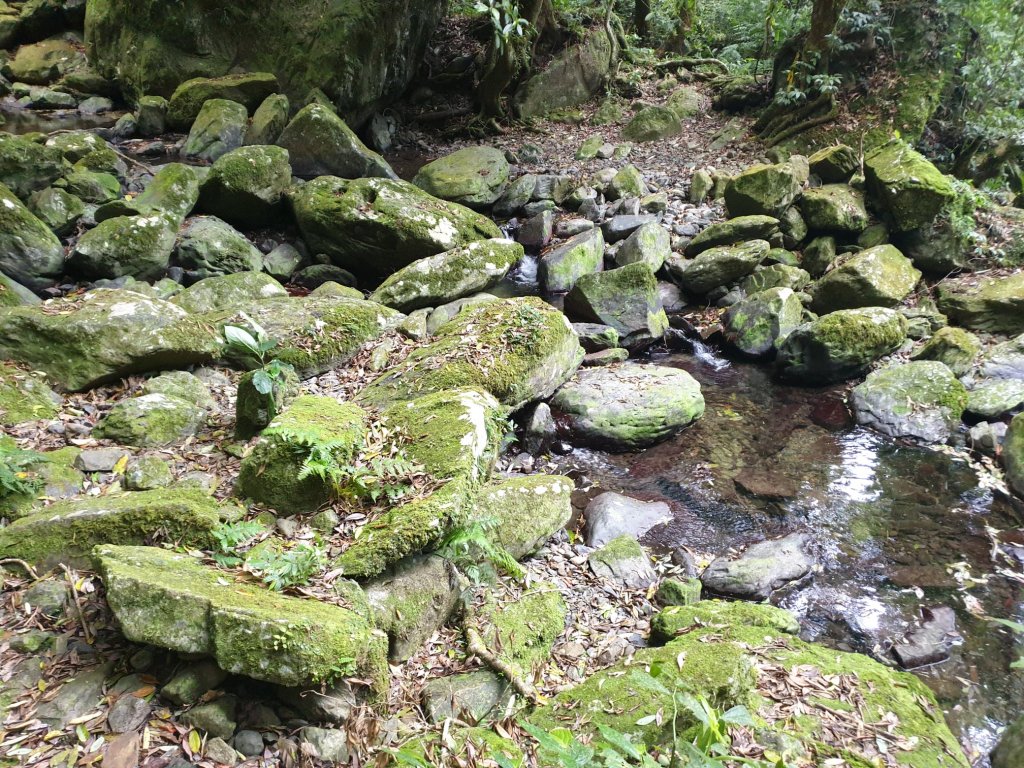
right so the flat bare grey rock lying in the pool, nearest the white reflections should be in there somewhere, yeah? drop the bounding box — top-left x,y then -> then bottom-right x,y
700,534 -> 814,600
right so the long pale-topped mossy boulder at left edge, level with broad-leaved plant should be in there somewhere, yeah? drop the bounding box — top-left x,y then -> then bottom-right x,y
0,289 -> 221,391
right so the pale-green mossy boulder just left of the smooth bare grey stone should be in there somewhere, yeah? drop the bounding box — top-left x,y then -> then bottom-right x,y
472,475 -> 574,560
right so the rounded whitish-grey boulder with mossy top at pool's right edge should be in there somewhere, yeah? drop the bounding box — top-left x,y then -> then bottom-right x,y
850,360 -> 968,442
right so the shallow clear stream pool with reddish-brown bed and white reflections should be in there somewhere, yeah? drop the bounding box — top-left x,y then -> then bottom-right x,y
559,349 -> 1024,765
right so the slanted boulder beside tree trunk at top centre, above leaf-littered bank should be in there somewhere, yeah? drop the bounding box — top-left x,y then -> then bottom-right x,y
512,28 -> 618,118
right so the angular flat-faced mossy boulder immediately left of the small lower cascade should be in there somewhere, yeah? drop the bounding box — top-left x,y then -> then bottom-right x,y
565,262 -> 669,347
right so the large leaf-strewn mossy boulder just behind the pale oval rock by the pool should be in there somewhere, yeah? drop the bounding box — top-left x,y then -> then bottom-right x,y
360,297 -> 583,411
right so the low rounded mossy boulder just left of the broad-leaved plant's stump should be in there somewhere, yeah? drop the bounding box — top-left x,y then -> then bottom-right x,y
93,393 -> 206,447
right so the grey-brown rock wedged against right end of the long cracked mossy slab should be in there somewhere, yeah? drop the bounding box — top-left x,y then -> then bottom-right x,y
364,555 -> 459,664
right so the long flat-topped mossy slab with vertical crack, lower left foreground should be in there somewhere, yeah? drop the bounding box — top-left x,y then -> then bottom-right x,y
95,547 -> 387,696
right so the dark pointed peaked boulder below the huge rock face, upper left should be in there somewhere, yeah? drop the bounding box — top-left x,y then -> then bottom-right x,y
276,103 -> 398,179
